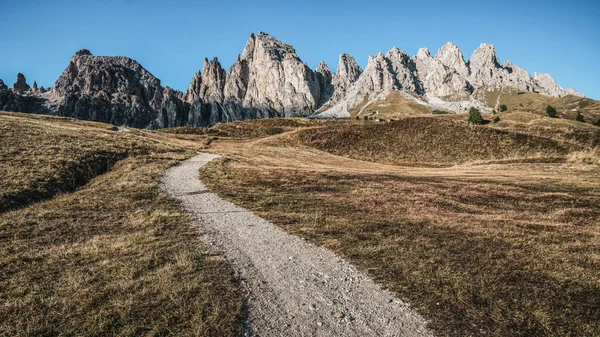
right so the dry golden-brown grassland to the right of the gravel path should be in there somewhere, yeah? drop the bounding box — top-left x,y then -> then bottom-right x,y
200,115 -> 600,336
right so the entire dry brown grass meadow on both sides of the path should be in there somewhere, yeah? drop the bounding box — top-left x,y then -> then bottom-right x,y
0,109 -> 600,336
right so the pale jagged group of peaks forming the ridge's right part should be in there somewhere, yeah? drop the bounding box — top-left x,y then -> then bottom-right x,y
322,42 -> 582,117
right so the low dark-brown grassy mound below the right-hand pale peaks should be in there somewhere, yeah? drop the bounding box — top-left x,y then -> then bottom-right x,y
297,117 -> 577,165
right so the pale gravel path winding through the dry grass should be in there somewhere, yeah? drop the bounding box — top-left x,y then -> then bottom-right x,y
162,153 -> 432,336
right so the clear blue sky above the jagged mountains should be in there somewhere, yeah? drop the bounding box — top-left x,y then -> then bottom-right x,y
0,0 -> 600,99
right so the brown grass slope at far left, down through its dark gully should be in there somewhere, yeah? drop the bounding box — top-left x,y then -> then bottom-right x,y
0,113 -> 174,212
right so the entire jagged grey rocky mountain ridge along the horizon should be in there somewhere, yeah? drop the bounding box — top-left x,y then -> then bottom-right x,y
0,32 -> 579,128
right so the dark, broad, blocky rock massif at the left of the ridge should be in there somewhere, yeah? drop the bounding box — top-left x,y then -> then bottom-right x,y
51,51 -> 163,128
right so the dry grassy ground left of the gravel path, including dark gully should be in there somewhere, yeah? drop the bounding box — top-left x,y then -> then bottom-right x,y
0,113 -> 242,336
